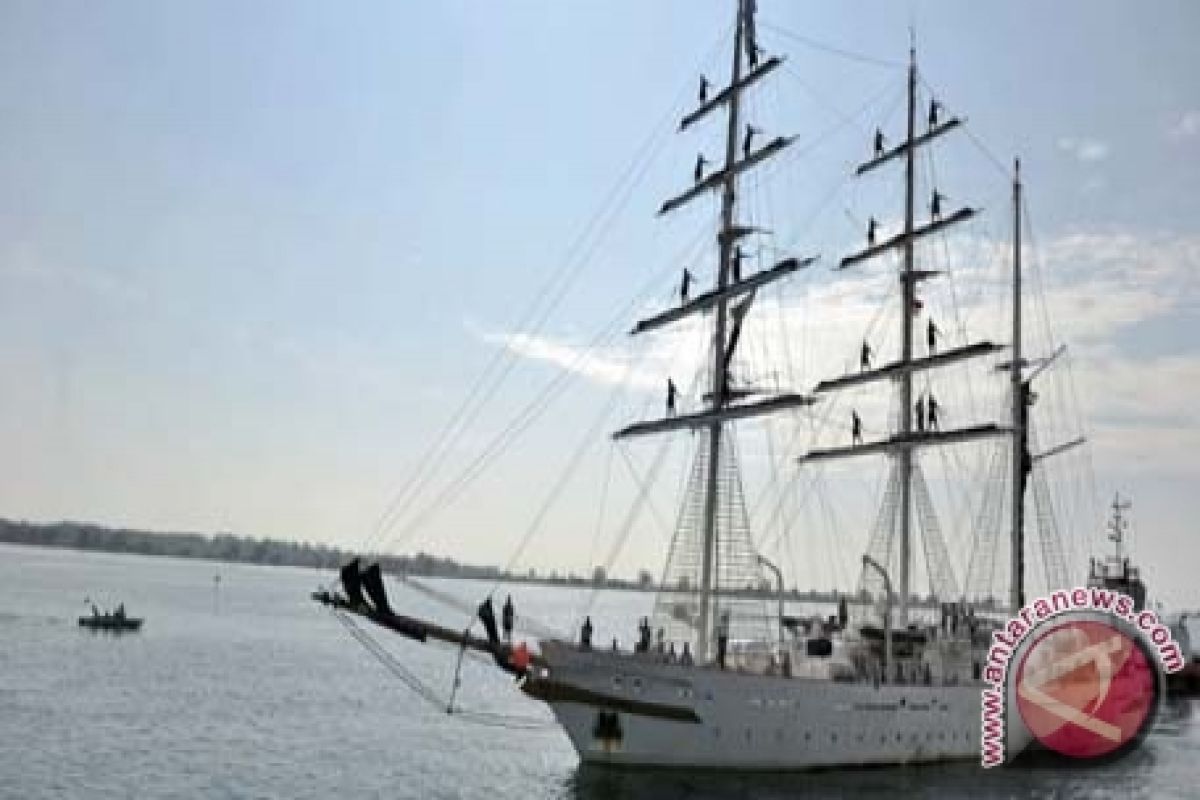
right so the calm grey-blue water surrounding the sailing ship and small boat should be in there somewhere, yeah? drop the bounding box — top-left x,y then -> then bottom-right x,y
0,546 -> 1200,799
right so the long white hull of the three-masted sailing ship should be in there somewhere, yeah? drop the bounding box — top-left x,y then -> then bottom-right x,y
527,643 -> 980,770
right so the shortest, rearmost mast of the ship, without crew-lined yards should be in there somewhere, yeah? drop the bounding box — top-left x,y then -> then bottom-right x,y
1009,160 -> 1028,613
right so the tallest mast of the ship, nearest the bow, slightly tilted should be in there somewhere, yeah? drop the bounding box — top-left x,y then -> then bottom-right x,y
696,0 -> 746,661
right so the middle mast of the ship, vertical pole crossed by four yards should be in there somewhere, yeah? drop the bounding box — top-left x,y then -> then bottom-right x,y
899,48 -> 917,627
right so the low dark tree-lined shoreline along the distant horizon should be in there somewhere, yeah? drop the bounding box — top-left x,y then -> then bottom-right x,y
0,519 -> 969,607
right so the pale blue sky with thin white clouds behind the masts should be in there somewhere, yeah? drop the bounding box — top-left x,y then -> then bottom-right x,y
0,0 -> 1200,607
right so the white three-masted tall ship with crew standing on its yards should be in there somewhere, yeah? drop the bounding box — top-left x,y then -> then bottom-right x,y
314,0 -> 1094,770
